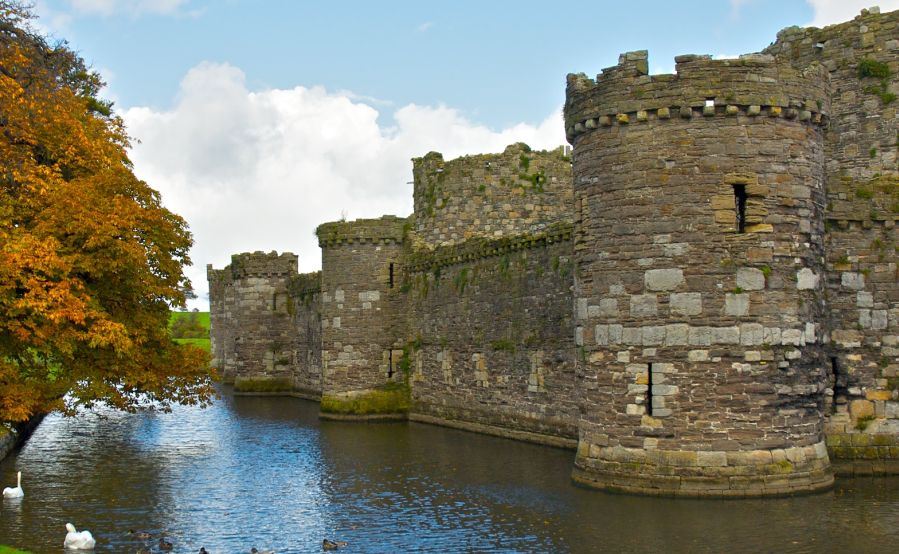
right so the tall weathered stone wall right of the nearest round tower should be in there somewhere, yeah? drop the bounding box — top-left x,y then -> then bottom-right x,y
765,5 -> 899,473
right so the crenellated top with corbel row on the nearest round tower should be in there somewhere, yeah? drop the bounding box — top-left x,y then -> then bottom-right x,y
565,50 -> 830,142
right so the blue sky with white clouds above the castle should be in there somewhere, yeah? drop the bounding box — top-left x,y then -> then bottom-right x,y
36,0 -> 899,310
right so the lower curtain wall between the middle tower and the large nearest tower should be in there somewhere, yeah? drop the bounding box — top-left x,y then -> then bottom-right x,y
404,225 -> 578,446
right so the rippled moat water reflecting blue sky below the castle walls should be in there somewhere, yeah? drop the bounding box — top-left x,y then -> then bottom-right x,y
0,393 -> 899,554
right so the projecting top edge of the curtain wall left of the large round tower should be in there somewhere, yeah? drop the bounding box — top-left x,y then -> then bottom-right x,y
406,222 -> 574,273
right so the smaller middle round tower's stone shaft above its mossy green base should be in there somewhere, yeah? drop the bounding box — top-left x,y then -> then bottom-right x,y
316,216 -> 407,399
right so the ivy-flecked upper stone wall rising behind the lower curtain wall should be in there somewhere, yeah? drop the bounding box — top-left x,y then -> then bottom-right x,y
412,143 -> 571,249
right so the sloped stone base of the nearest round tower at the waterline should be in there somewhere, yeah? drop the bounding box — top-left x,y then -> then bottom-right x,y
572,442 -> 833,497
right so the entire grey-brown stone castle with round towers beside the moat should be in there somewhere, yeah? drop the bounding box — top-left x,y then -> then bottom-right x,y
207,9 -> 899,496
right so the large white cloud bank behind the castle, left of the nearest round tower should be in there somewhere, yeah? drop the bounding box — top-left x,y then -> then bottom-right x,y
123,63 -> 564,306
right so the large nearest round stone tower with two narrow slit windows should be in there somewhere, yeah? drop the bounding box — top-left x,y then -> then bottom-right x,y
565,51 -> 833,496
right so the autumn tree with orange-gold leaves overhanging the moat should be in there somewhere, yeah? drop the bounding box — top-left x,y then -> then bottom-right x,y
0,0 -> 212,421
